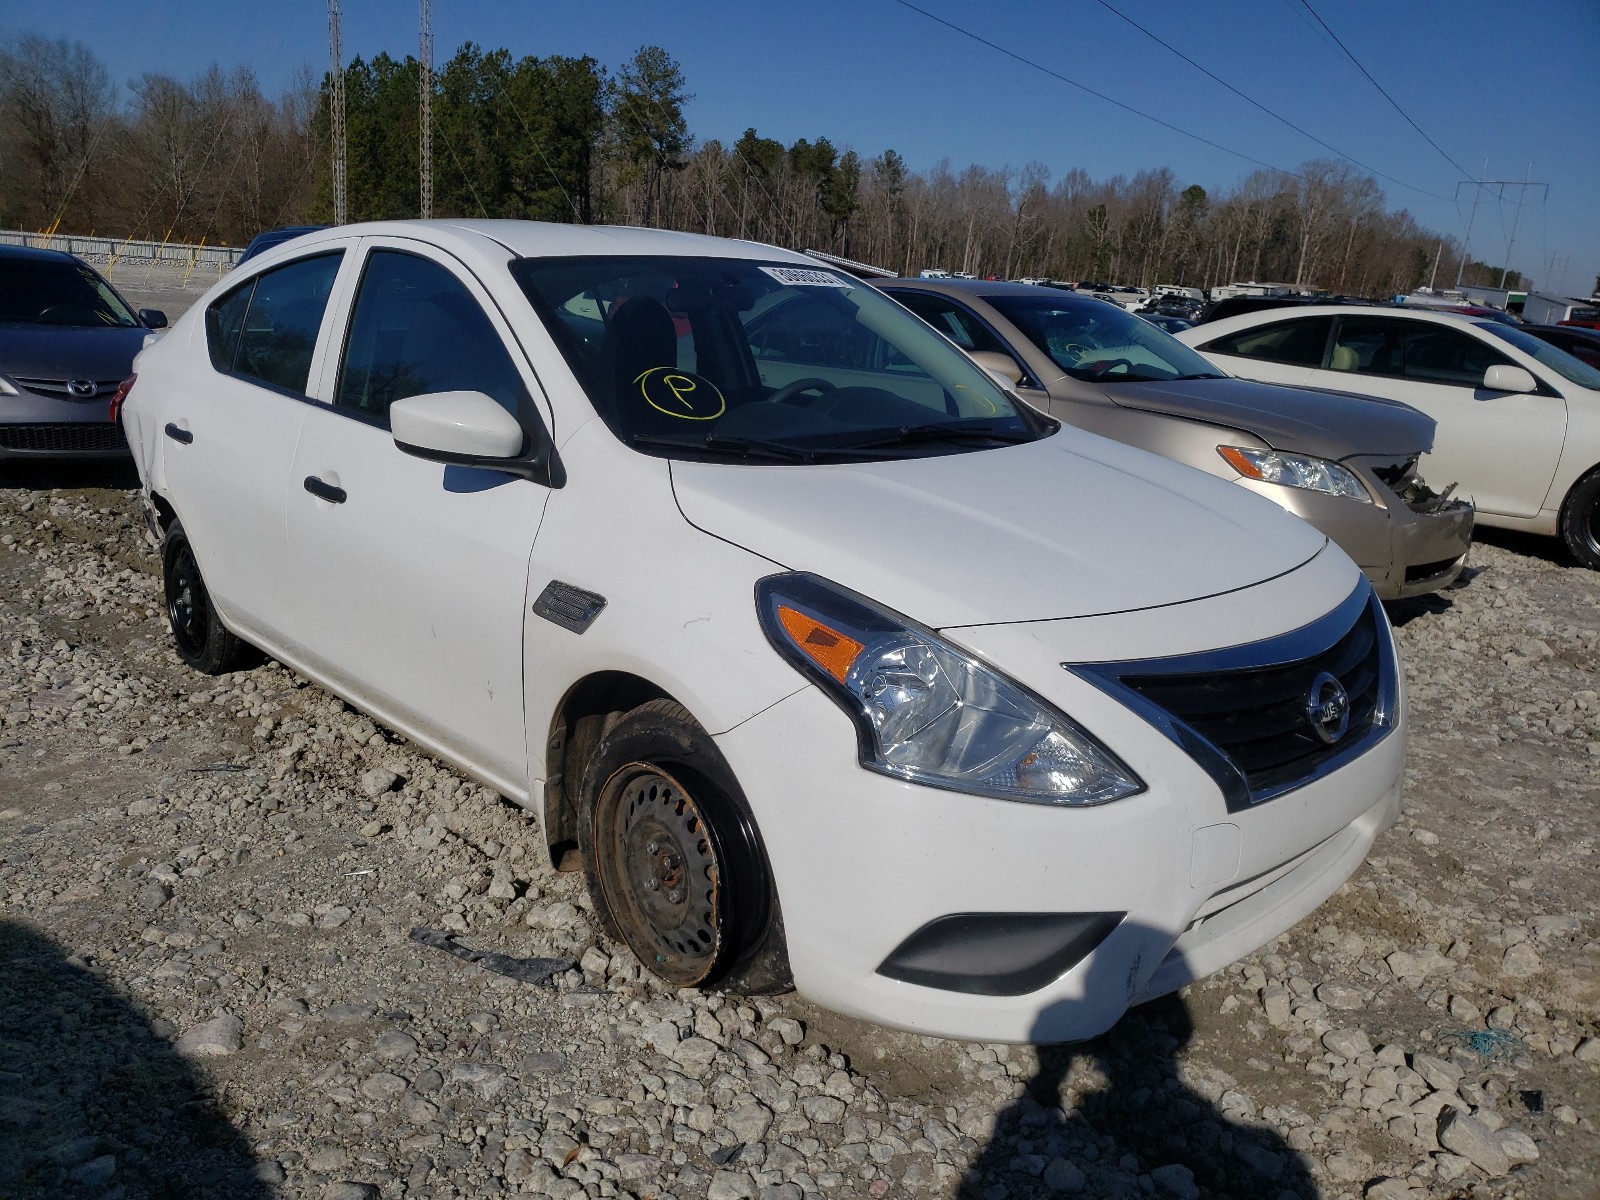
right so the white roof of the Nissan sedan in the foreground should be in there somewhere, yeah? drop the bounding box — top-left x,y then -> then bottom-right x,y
272,221 -> 812,270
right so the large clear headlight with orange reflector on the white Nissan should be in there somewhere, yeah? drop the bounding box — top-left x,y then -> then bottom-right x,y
755,574 -> 1144,806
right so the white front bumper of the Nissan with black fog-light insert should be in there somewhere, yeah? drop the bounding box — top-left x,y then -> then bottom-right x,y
717,566 -> 1406,1043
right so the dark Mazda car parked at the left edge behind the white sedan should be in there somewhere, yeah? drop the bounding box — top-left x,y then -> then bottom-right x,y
0,246 -> 166,461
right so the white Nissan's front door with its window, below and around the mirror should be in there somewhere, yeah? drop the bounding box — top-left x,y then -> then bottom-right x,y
288,238 -> 549,798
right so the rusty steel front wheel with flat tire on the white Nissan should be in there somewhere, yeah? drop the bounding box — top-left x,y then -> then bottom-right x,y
579,699 -> 790,994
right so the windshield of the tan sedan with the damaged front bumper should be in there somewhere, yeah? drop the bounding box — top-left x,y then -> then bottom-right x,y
984,296 -> 1222,384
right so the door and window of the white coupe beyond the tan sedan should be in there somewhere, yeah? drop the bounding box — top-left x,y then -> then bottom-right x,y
1306,315 -> 1566,517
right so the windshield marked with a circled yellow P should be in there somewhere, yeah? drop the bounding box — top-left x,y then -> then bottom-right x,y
512,258 -> 1058,462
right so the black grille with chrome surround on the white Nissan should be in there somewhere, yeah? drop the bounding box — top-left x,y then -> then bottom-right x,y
1074,584 -> 1397,811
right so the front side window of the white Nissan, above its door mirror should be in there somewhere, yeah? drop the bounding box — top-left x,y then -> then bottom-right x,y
334,250 -> 531,426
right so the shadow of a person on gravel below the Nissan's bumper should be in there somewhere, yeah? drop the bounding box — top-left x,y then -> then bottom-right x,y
957,940 -> 1322,1200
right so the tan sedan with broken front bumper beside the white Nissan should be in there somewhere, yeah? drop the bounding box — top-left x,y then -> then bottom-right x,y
875,278 -> 1474,600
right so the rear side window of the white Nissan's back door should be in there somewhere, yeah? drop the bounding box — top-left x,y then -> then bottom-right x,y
206,253 -> 342,394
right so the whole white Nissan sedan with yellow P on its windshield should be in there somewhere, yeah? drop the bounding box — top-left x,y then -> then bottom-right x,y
122,221 -> 1405,1042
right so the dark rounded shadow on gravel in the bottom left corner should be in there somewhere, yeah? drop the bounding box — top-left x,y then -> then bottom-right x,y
0,920 -> 272,1200
